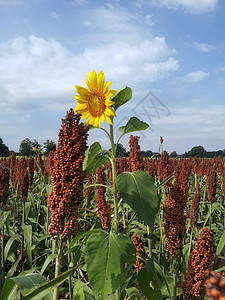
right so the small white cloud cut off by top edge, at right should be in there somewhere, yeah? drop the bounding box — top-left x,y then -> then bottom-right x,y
154,0 -> 218,13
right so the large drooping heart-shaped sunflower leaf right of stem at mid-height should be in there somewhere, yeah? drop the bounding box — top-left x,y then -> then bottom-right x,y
117,171 -> 158,230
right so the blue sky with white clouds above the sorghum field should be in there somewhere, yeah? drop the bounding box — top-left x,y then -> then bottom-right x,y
0,0 -> 225,154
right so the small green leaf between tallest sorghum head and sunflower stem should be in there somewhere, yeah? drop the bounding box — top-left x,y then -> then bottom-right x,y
83,142 -> 109,175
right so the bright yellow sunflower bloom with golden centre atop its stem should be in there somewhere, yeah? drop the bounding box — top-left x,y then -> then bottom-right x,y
75,70 -> 116,127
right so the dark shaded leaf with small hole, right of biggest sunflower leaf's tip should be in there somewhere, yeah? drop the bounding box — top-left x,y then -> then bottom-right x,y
138,259 -> 162,299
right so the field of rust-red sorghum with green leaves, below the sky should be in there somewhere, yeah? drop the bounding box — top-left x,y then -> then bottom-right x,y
0,110 -> 225,300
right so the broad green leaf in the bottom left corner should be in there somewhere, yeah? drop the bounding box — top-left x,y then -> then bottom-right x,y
1,274 -> 52,300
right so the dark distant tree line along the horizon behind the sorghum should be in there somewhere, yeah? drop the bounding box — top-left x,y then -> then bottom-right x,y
0,137 -> 225,158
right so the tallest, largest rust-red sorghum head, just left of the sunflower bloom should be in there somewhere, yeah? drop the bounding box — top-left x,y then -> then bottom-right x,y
48,108 -> 89,238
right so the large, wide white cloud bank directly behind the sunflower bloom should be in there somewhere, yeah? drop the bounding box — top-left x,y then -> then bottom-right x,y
0,31 -> 179,107
